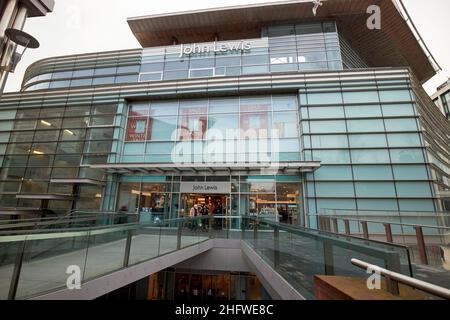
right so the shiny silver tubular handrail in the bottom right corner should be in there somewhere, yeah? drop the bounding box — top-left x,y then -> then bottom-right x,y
351,259 -> 450,300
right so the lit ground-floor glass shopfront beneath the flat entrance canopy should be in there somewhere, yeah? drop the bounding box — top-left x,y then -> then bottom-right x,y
117,175 -> 304,227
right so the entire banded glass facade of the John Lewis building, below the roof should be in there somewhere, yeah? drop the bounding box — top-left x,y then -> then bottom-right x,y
0,21 -> 442,227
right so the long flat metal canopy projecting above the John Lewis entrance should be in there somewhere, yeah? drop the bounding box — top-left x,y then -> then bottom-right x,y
90,162 -> 320,176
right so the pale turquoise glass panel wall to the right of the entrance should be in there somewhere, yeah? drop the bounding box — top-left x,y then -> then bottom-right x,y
300,80 -> 435,223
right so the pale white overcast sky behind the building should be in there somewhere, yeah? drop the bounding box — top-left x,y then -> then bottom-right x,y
5,0 -> 450,94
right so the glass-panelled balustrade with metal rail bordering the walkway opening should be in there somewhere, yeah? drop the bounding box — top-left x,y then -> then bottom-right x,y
0,216 -> 412,299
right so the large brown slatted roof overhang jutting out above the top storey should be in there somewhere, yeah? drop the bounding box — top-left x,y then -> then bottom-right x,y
128,0 -> 436,82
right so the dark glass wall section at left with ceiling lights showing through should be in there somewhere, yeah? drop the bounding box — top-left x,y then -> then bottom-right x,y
0,104 -> 118,212
